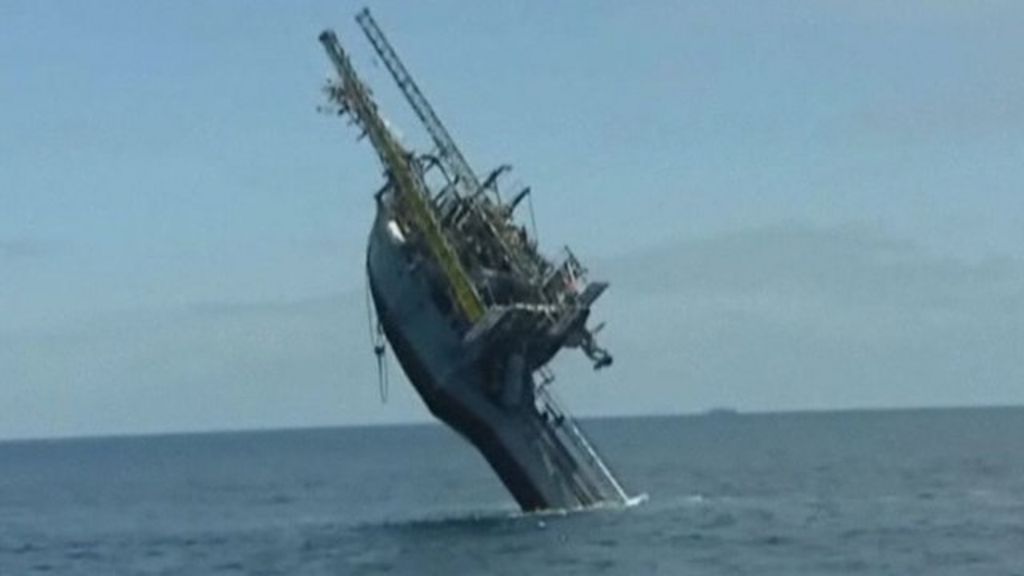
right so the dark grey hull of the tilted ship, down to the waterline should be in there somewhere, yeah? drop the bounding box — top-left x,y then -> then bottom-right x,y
367,204 -> 627,510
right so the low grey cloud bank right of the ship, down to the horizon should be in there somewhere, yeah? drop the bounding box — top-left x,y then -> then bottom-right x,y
563,224 -> 1024,412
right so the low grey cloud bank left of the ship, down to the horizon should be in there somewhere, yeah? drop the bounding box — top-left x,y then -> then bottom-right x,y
0,292 -> 426,438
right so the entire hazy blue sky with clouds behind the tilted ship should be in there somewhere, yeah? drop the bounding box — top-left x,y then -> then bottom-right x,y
0,0 -> 1024,439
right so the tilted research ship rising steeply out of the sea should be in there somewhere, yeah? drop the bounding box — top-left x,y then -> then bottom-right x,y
319,9 -> 627,510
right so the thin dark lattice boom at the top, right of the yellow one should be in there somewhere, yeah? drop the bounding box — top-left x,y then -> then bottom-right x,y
355,8 -> 480,196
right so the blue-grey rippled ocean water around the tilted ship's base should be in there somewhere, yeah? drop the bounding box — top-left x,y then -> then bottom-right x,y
0,409 -> 1024,576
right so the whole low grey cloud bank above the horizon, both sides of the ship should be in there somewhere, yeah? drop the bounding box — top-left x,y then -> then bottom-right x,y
0,223 -> 1024,437
